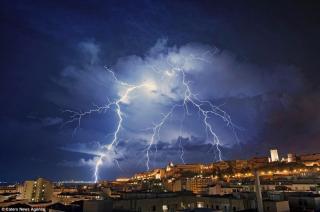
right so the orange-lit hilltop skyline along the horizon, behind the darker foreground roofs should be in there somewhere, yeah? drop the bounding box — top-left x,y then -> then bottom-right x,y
0,148 -> 320,185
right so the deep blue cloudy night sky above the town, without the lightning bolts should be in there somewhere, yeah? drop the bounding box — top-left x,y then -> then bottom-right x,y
0,0 -> 320,182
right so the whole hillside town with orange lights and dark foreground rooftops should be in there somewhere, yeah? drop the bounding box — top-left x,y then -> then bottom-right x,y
0,149 -> 320,212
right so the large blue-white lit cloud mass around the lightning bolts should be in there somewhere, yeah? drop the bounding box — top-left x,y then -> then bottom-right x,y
48,39 -> 303,176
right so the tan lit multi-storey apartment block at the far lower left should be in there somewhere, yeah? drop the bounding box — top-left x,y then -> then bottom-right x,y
23,178 -> 53,203
